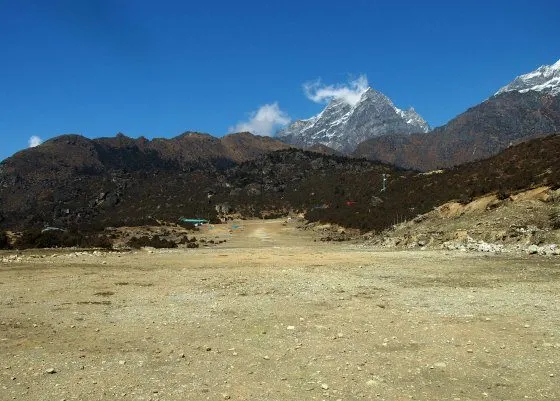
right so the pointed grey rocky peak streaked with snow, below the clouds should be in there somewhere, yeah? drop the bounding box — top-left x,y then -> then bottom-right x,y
277,88 -> 429,153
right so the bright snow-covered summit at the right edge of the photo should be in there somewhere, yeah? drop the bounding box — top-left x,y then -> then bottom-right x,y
496,60 -> 560,95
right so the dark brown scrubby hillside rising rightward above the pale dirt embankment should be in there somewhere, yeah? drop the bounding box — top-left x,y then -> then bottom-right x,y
306,135 -> 560,230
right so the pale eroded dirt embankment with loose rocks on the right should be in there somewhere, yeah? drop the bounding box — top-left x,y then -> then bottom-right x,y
373,187 -> 560,255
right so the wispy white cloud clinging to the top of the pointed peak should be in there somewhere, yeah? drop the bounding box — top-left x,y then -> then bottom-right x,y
303,75 -> 368,106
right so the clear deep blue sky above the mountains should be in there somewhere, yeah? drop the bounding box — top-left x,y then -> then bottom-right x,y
0,0 -> 560,160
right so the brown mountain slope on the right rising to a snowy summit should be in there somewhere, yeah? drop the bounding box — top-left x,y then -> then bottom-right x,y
353,63 -> 560,171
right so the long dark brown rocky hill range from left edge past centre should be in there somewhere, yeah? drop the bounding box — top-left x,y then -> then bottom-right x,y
0,133 -> 402,230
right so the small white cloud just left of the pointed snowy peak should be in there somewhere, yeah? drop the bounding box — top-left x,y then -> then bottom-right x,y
229,103 -> 291,136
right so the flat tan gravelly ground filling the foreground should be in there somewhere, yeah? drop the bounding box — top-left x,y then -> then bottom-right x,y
0,220 -> 560,400
